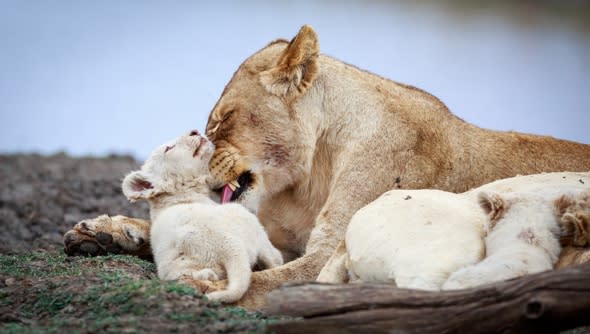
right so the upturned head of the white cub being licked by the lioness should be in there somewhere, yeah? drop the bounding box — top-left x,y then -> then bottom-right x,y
122,131 -> 215,201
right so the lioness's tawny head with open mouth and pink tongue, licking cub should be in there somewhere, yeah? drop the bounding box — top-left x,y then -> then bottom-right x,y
207,26 -> 319,212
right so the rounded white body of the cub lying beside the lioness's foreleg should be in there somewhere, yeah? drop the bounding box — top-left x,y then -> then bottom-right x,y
318,190 -> 484,290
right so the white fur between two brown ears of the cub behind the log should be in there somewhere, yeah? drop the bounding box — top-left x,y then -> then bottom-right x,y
442,192 -> 561,289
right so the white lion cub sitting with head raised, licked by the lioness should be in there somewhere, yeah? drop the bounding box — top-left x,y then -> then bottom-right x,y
122,131 -> 283,303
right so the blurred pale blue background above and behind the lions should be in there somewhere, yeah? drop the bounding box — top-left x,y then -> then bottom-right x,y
0,0 -> 590,160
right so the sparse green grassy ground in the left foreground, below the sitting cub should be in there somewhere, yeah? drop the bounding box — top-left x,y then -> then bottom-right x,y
0,253 -> 286,333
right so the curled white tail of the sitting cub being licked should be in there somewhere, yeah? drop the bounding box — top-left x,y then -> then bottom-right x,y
207,252 -> 252,303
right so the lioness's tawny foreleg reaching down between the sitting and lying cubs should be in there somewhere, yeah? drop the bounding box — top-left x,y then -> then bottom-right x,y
238,157 -> 430,308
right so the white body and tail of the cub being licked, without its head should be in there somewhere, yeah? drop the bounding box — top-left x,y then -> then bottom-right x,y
151,201 -> 283,303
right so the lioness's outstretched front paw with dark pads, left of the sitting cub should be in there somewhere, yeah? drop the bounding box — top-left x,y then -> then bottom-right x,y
64,215 -> 152,259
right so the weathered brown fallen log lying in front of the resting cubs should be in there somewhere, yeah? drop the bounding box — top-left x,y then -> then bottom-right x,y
267,263 -> 590,333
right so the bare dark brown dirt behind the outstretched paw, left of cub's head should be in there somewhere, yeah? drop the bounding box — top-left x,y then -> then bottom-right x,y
0,154 -> 148,254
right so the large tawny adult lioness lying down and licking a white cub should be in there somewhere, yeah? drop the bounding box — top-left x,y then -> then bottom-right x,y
67,26 -> 590,307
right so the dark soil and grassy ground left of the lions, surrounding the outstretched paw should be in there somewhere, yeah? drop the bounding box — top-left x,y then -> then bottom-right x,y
0,154 -> 286,333
